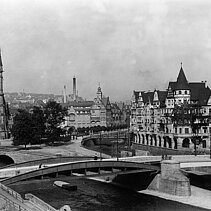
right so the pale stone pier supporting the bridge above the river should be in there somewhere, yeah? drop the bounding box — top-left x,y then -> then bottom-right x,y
148,160 -> 191,196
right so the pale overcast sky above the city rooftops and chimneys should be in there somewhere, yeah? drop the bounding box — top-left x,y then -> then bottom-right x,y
0,0 -> 211,100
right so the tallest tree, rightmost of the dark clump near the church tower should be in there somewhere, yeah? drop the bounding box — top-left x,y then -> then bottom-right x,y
44,101 -> 67,144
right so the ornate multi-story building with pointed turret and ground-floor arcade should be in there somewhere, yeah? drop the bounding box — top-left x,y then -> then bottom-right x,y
130,66 -> 211,149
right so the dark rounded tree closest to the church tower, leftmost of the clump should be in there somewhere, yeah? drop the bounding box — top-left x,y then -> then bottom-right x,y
11,109 -> 33,149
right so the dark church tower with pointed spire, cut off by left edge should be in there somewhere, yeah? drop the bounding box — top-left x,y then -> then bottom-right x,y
0,51 -> 9,138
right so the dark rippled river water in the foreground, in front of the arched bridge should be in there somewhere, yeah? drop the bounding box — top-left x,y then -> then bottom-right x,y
9,177 -> 209,211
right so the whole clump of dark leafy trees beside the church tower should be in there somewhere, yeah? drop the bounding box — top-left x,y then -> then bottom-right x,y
11,101 -> 67,147
